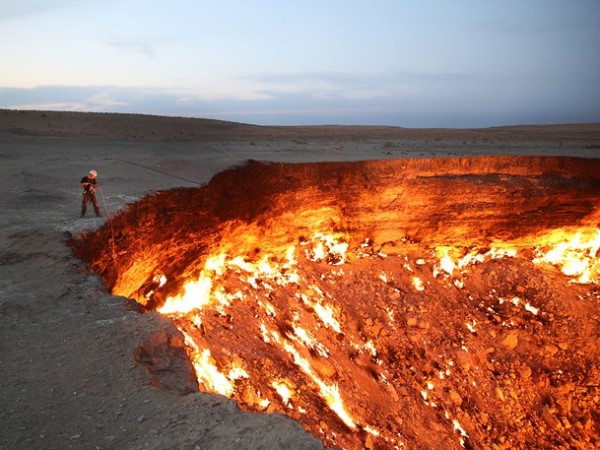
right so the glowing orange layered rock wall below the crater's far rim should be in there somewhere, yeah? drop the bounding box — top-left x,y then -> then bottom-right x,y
75,156 -> 600,303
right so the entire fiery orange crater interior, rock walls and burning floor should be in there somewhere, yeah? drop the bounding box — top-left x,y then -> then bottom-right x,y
74,156 -> 600,448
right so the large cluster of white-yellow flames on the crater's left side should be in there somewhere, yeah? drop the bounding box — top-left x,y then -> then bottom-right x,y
158,234 -> 372,442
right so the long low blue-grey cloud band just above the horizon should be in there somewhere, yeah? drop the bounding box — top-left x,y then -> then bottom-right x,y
0,82 -> 600,128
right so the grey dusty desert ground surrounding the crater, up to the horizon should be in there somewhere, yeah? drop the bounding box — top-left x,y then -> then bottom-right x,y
0,111 -> 600,449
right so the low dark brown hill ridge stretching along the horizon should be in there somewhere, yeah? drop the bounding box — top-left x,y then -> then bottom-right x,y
0,109 -> 600,145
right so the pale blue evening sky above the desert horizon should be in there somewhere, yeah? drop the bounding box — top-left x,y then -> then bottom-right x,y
0,0 -> 600,128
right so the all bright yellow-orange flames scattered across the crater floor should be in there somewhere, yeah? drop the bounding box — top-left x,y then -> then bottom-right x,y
159,229 -> 600,448
